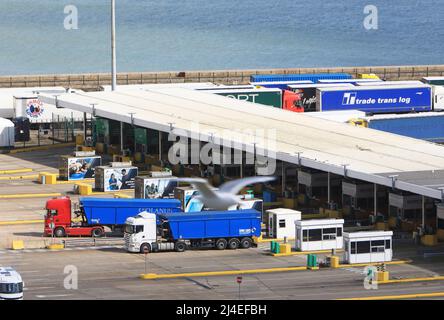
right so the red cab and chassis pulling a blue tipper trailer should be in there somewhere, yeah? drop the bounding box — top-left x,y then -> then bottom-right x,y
44,197 -> 105,237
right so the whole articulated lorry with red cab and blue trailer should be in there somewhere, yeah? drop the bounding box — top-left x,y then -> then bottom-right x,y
44,197 -> 182,237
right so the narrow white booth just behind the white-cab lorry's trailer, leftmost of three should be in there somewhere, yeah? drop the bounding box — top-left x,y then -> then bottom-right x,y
267,208 -> 301,239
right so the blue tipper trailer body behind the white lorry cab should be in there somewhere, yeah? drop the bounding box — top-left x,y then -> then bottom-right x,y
159,209 -> 261,240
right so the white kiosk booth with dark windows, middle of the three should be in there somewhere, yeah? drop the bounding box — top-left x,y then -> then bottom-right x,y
295,219 -> 344,251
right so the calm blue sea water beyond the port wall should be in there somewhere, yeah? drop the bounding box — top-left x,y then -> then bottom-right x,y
0,0 -> 444,75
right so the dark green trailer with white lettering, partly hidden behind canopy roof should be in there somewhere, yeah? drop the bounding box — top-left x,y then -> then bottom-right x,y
205,88 -> 282,108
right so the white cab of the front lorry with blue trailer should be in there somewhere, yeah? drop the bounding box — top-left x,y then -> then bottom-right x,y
124,211 -> 157,252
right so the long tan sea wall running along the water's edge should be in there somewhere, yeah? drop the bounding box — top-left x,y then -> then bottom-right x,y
0,65 -> 444,90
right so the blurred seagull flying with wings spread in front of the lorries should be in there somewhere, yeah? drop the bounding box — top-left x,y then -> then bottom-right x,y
177,176 -> 276,211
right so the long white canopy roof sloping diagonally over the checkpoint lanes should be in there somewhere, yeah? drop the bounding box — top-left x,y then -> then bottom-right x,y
40,88 -> 444,199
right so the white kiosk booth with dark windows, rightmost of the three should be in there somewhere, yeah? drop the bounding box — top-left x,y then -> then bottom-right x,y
344,231 -> 393,263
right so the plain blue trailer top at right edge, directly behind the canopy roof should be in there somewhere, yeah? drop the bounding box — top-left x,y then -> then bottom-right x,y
368,113 -> 444,143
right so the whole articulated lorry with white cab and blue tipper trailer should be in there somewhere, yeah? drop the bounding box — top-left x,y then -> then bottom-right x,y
124,210 -> 261,253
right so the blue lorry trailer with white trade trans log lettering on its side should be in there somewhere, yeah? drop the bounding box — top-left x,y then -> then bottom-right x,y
317,87 -> 432,113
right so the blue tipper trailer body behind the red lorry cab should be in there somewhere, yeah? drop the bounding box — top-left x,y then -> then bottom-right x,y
80,198 -> 182,225
